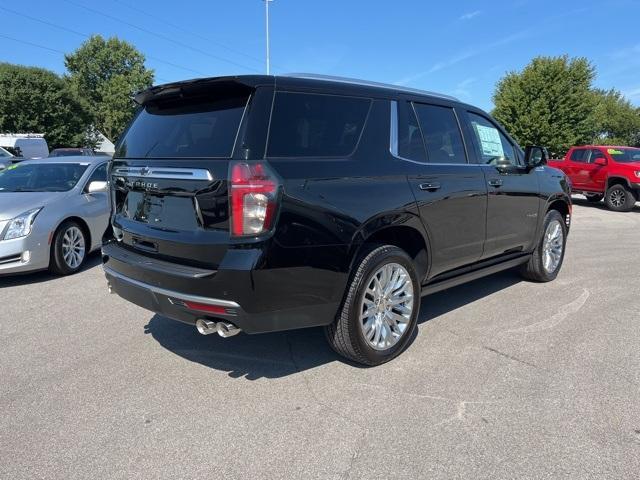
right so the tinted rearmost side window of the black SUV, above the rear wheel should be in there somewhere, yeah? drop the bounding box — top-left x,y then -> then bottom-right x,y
267,92 -> 371,157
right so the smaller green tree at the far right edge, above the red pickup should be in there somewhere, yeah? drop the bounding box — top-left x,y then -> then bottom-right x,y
592,90 -> 640,146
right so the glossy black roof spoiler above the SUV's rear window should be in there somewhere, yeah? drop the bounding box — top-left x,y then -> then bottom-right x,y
133,75 -> 275,105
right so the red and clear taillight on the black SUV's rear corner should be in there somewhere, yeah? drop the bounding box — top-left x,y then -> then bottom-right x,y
229,162 -> 279,237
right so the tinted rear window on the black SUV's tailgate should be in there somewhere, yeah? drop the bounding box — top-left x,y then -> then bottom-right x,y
115,96 -> 248,158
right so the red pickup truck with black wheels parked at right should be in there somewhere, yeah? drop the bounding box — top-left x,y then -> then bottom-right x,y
548,145 -> 640,212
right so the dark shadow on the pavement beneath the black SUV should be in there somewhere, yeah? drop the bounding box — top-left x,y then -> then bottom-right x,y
145,270 -> 521,380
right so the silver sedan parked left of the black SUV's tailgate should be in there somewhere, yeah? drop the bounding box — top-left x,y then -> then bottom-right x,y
0,157 -> 109,275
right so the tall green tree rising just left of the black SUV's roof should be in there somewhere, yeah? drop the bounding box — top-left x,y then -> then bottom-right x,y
65,35 -> 154,142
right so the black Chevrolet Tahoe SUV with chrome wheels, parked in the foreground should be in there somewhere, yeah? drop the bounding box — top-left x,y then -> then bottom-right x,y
103,75 -> 571,365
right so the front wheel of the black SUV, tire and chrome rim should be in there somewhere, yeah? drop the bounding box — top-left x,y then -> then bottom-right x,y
521,210 -> 567,282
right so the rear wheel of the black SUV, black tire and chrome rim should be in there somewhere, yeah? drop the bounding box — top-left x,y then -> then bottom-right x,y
325,245 -> 420,366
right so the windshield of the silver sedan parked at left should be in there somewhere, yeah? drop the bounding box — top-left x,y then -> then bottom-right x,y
0,163 -> 87,193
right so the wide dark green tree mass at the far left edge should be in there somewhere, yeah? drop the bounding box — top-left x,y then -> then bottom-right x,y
0,63 -> 93,148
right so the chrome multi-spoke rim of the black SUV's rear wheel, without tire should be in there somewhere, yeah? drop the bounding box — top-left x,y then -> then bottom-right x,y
359,263 -> 414,350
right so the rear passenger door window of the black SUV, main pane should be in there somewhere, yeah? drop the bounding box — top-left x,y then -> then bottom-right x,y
414,103 -> 467,163
